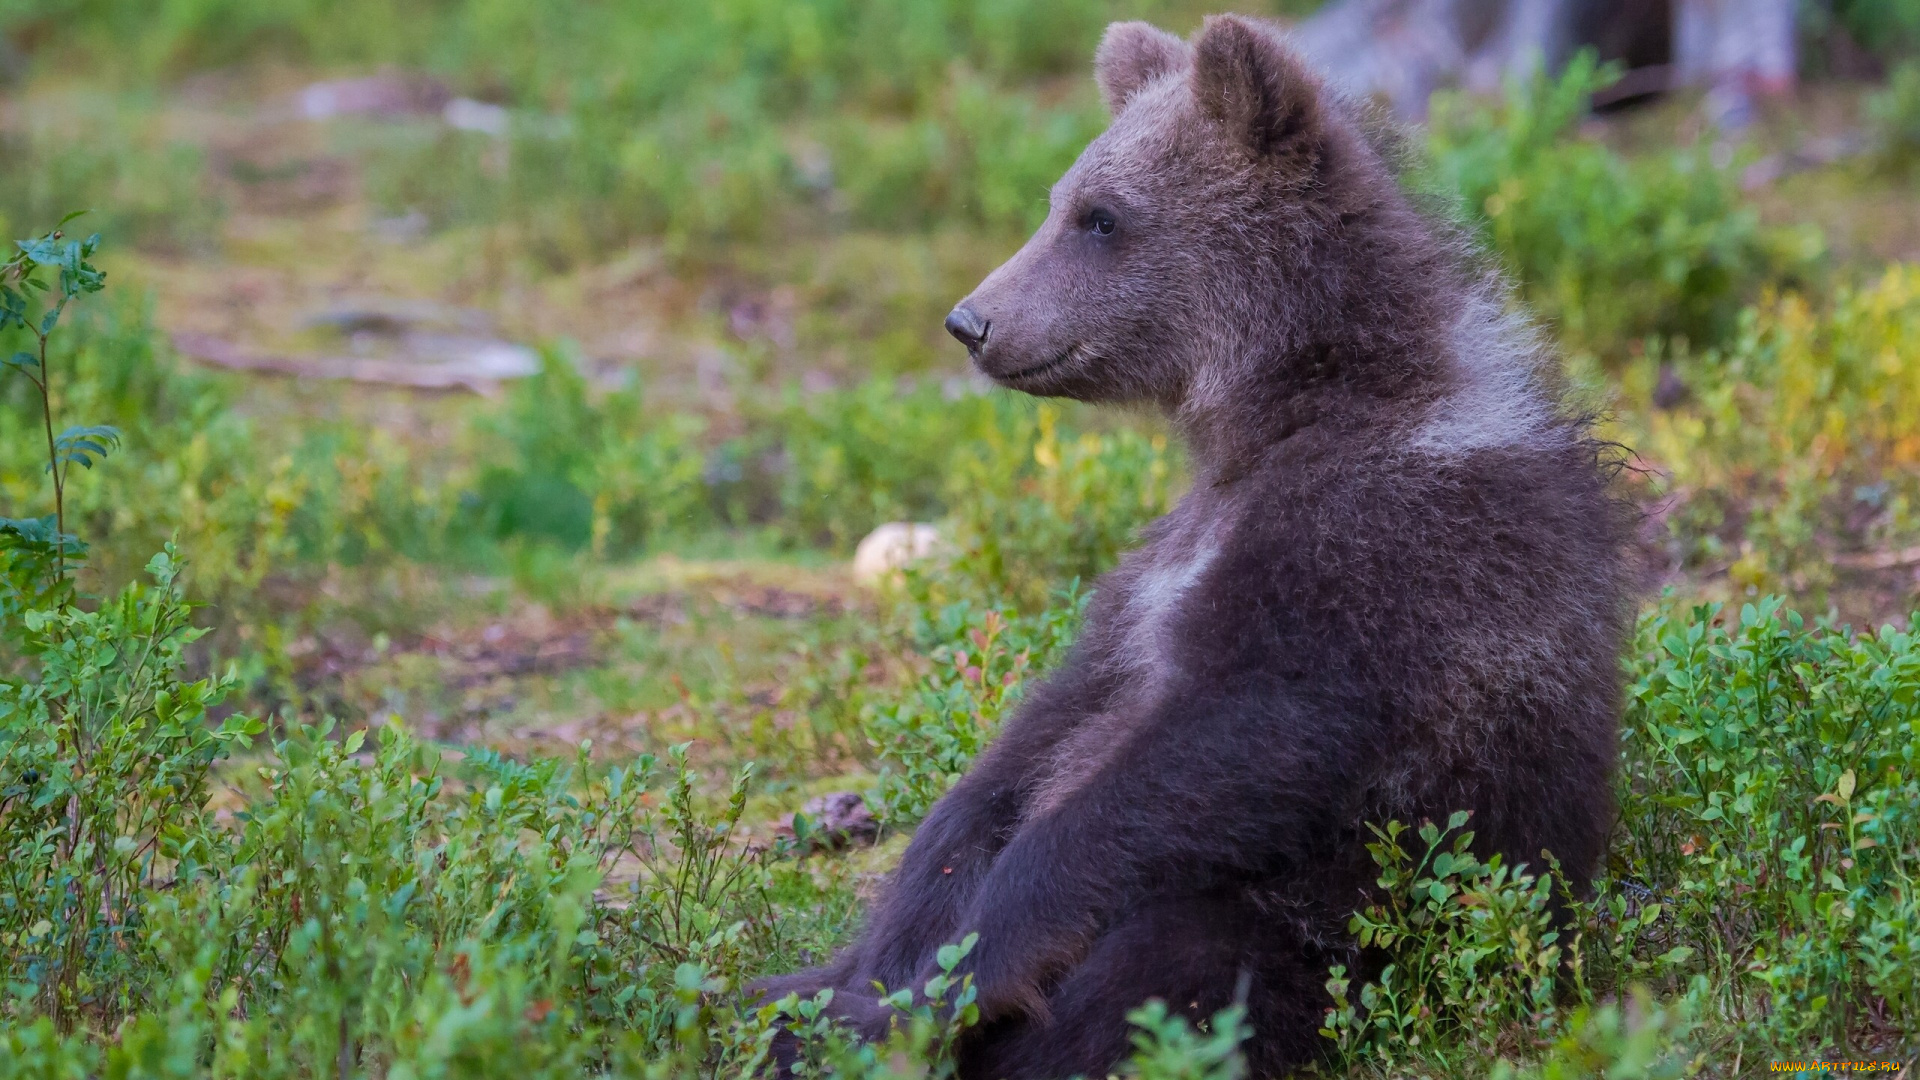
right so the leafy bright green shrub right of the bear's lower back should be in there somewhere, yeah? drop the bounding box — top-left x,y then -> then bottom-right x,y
1613,600 -> 1920,1049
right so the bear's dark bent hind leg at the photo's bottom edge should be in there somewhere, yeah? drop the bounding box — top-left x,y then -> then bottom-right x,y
960,894 -> 1336,1080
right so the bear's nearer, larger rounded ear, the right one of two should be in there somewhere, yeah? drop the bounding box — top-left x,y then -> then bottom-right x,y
1192,15 -> 1319,158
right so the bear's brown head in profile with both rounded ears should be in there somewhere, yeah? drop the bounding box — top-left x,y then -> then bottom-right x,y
947,15 -> 1428,420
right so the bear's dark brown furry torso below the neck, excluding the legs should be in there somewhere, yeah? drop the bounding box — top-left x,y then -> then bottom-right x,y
1066,395 -> 1630,867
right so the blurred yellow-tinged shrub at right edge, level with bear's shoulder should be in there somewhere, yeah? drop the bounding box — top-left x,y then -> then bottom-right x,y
1617,265 -> 1920,600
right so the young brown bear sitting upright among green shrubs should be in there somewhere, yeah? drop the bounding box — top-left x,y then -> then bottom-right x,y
764,15 -> 1632,1080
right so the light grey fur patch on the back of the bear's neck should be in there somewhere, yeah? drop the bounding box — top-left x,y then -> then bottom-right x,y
1409,294 -> 1553,454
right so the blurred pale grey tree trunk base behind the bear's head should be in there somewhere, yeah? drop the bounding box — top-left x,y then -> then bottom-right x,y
1294,0 -> 1795,123
